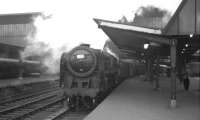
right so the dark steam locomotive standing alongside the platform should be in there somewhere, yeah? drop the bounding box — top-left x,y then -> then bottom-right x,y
60,44 -> 118,108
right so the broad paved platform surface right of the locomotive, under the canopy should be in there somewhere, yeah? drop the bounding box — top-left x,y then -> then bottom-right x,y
84,77 -> 200,120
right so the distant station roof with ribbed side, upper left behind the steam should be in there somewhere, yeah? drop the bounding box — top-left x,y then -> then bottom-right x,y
0,12 -> 41,48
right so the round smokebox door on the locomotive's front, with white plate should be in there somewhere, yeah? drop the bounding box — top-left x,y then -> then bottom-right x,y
67,46 -> 97,77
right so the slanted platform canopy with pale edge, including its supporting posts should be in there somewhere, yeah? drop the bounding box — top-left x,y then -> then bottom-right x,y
94,19 -> 177,106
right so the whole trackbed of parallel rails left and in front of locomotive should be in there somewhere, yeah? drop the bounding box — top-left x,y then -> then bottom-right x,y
0,78 -> 122,120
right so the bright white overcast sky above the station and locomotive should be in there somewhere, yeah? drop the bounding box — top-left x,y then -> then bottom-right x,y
0,0 -> 181,48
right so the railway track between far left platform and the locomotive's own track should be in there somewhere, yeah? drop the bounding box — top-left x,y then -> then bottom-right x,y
0,90 -> 62,120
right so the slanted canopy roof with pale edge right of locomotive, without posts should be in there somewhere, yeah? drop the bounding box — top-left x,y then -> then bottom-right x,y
94,19 -> 170,56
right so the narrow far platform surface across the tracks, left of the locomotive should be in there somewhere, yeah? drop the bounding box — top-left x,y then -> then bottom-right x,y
0,75 -> 59,88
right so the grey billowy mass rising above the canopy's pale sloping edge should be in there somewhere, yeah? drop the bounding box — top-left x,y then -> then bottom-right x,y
118,6 -> 171,29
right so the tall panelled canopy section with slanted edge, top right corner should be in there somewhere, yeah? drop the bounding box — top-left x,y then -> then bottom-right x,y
162,0 -> 200,35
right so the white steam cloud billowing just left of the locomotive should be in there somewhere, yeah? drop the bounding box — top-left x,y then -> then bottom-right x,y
22,13 -> 80,74
